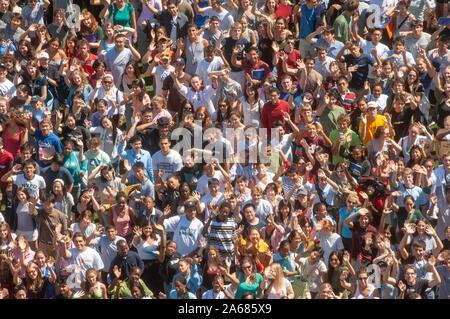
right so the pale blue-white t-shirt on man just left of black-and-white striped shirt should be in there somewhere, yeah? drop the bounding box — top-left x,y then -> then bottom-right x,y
164,215 -> 203,256
